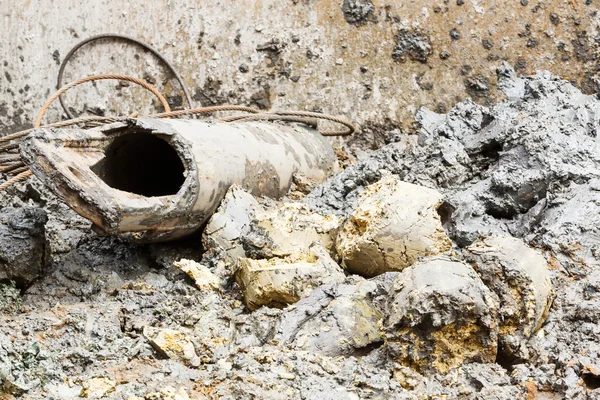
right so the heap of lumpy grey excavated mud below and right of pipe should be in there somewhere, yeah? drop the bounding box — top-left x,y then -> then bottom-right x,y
0,65 -> 600,399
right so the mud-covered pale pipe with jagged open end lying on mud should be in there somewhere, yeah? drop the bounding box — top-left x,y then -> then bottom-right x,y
20,119 -> 335,242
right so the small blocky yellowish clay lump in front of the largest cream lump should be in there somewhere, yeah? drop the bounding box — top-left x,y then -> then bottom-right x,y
236,245 -> 344,310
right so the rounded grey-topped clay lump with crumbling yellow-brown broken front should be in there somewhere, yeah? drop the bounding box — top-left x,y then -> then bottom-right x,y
385,257 -> 498,373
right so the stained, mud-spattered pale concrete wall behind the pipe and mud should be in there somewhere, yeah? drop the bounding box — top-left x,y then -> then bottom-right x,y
0,0 -> 600,146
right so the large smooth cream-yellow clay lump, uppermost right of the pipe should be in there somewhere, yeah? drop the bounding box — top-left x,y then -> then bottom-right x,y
336,175 -> 452,276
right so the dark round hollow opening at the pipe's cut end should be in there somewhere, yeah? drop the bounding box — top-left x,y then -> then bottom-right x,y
92,133 -> 185,197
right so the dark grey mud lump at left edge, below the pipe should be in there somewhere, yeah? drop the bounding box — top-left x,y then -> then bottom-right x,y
0,207 -> 48,286
